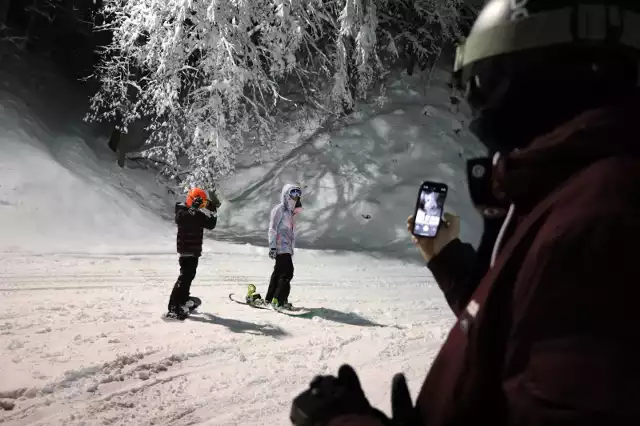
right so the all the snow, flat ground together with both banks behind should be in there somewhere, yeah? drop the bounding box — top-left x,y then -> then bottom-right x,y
0,49 -> 478,426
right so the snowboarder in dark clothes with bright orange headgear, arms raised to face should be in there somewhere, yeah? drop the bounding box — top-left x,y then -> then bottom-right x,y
167,188 -> 219,320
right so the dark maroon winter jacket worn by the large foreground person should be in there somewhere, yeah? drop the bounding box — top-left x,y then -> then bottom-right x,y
330,91 -> 640,426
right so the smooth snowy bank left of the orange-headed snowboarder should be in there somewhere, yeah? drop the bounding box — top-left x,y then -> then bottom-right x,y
0,52 -> 172,251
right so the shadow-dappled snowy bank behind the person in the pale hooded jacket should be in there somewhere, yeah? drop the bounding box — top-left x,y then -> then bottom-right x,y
215,70 -> 484,258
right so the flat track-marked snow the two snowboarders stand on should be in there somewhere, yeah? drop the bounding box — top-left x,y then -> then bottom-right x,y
0,251 -> 453,426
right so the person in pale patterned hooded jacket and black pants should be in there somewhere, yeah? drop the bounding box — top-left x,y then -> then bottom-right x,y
265,184 -> 302,309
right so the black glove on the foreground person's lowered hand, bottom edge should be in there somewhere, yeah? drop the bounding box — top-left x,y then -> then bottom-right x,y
290,364 -> 416,426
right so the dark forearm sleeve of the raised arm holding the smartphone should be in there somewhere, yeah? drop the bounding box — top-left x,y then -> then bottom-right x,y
427,238 -> 478,316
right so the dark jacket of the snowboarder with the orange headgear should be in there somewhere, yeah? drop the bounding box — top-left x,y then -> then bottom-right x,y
175,203 -> 218,257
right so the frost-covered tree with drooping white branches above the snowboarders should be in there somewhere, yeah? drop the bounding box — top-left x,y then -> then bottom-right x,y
87,0 -> 460,190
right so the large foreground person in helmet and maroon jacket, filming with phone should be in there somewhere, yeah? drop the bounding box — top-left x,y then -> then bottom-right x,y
290,0 -> 640,426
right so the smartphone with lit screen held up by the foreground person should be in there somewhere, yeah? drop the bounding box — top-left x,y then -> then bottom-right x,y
412,181 -> 449,238
